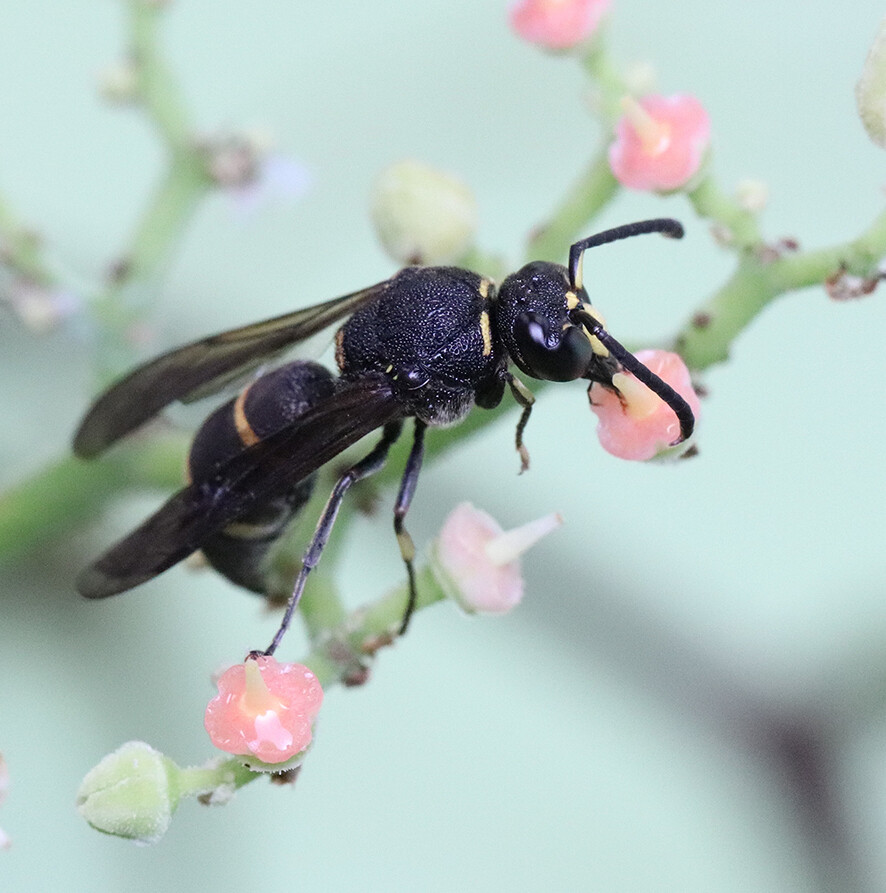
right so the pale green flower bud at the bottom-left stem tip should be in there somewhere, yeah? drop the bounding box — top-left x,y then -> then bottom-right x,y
77,741 -> 180,843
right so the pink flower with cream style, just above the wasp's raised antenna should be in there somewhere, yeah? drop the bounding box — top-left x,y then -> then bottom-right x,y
609,93 -> 711,192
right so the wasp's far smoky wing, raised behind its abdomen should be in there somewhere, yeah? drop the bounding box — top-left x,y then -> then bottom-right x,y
74,280 -> 387,459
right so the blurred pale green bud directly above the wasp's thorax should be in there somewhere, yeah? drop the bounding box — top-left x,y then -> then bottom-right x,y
370,160 -> 477,264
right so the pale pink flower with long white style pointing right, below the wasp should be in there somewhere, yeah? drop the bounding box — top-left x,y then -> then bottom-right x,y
431,502 -> 563,614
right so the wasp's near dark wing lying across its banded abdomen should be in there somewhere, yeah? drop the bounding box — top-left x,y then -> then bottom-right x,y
77,378 -> 404,598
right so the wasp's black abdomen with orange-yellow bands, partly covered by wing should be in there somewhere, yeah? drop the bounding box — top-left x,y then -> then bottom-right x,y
188,361 -> 335,593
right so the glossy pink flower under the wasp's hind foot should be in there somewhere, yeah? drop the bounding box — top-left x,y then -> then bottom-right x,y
204,655 -> 323,768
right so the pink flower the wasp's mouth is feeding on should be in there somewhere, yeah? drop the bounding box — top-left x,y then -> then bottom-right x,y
588,350 -> 700,461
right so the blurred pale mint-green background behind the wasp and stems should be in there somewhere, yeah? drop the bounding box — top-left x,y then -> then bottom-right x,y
0,0 -> 886,893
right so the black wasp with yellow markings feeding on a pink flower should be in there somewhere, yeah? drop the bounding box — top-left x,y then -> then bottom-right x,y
74,219 -> 695,653
